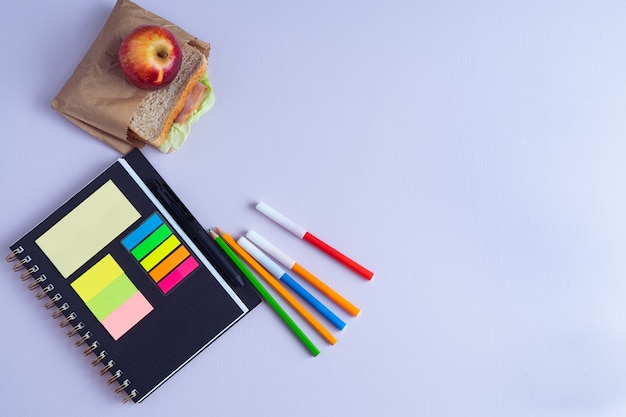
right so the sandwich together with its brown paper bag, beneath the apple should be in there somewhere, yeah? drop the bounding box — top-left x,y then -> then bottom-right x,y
51,0 -> 215,154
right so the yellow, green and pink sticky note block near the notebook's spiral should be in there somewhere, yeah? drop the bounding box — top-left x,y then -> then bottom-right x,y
71,254 -> 153,340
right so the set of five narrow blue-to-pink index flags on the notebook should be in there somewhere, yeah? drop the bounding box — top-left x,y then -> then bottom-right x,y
122,213 -> 199,293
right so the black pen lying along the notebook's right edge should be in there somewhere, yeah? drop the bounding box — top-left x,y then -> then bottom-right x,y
154,179 -> 244,287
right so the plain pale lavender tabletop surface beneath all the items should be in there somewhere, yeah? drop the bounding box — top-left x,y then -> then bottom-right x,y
0,0 -> 626,417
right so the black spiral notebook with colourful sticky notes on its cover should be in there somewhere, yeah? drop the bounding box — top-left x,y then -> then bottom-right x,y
7,149 -> 260,402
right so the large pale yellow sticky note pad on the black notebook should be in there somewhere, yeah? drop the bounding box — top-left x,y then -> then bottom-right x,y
35,180 -> 141,278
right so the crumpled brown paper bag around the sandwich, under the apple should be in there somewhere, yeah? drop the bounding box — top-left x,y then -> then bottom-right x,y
51,0 -> 210,154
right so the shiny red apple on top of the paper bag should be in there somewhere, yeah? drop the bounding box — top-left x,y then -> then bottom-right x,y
118,25 -> 183,90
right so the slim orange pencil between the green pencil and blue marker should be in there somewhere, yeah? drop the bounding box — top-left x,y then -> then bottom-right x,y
215,227 -> 337,345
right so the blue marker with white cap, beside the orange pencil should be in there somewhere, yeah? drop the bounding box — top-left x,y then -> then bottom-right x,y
237,236 -> 346,330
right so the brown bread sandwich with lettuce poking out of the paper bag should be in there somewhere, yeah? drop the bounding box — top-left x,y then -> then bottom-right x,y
127,43 -> 215,153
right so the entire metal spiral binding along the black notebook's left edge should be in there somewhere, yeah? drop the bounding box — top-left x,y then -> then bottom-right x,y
6,250 -> 139,403
